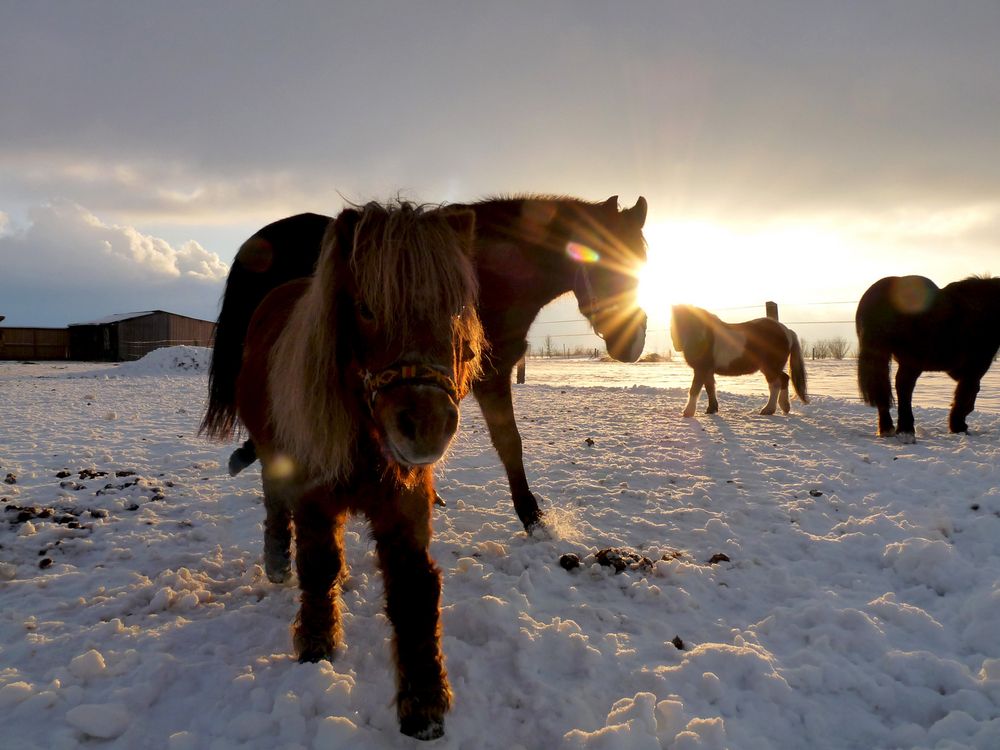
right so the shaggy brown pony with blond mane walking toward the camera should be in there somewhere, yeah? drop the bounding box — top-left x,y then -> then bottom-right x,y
208,203 -> 483,739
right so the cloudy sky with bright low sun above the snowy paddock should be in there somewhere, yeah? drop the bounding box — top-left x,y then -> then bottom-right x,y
0,0 -> 1000,350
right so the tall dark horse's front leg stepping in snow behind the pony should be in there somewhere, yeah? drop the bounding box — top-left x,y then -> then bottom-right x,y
473,373 -> 542,534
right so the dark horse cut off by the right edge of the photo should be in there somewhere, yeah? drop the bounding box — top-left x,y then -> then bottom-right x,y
854,276 -> 1000,443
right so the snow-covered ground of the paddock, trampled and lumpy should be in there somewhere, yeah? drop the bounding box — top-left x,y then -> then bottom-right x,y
0,350 -> 1000,750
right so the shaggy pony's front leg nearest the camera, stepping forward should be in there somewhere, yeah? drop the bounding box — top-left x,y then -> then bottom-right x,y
369,488 -> 451,740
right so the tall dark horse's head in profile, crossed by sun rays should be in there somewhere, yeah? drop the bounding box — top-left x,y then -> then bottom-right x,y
566,196 -> 646,362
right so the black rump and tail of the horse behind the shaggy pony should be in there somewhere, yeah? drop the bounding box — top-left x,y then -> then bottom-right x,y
198,214 -> 330,440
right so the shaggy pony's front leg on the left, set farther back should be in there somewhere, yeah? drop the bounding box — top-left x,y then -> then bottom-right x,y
292,491 -> 347,662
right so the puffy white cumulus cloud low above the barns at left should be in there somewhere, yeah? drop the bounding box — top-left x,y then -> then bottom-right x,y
0,201 -> 229,326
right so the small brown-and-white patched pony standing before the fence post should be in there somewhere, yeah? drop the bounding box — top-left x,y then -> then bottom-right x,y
670,305 -> 809,424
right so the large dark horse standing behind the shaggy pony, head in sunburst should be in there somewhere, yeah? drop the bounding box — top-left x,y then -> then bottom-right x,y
202,196 -> 646,533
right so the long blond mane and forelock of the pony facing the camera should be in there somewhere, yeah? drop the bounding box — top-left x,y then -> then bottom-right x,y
268,202 -> 483,481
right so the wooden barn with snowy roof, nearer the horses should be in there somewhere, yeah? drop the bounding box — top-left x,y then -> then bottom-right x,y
69,310 -> 215,362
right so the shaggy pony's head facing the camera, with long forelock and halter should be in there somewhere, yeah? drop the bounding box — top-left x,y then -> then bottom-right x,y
328,204 -> 483,468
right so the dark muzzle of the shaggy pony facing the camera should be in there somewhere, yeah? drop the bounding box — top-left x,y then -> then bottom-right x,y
372,384 -> 458,466
